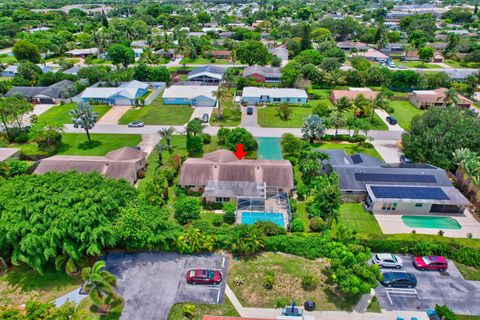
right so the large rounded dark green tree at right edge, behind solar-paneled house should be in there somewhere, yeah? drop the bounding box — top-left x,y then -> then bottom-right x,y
402,107 -> 480,170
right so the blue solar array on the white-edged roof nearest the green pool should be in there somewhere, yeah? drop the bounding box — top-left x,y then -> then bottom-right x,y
371,186 -> 449,200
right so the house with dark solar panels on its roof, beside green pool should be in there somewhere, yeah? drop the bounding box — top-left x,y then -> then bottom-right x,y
317,150 -> 470,214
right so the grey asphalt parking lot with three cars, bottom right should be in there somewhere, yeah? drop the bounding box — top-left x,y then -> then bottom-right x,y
375,255 -> 480,315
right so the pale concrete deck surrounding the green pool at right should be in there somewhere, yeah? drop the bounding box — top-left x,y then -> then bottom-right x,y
374,211 -> 480,239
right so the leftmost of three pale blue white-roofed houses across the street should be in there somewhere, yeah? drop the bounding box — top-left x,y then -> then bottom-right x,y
80,80 -> 165,106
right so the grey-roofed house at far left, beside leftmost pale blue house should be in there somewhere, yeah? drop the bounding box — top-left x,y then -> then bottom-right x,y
5,80 -> 77,104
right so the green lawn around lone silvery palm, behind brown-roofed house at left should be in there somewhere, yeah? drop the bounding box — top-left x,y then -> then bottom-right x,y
58,133 -> 142,156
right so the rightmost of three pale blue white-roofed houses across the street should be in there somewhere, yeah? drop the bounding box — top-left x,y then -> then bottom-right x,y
242,87 -> 308,105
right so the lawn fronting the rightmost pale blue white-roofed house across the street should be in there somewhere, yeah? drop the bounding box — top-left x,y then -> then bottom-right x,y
257,106 -> 312,128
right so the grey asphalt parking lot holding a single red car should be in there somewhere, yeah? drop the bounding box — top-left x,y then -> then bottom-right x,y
105,252 -> 228,320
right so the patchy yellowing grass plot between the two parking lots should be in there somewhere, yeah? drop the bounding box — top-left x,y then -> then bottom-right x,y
228,252 -> 357,310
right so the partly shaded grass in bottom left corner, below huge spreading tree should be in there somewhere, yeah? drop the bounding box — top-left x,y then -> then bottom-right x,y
0,265 -> 81,307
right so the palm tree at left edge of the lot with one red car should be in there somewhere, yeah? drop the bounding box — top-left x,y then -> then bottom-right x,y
82,261 -> 117,306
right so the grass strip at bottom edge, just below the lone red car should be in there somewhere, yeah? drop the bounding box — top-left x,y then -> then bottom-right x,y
167,296 -> 239,320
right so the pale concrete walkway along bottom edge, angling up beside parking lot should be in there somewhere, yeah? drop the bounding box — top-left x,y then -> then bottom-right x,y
225,285 -> 428,320
